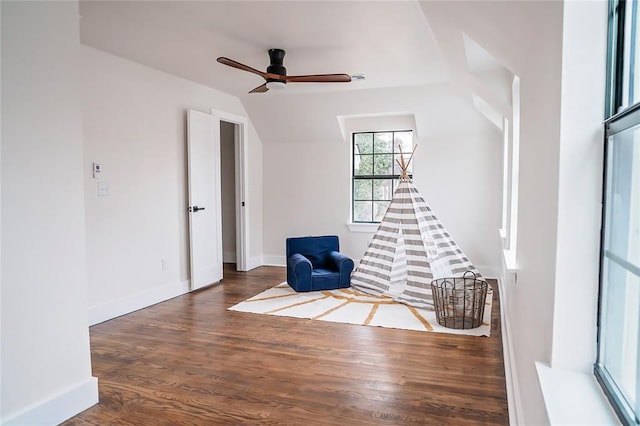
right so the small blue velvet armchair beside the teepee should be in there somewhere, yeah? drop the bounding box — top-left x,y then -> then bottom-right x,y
287,235 -> 353,291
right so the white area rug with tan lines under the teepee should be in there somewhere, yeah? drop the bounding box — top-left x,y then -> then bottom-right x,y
229,282 -> 493,336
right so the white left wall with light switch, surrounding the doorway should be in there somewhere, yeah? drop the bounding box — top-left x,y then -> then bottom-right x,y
81,46 -> 262,322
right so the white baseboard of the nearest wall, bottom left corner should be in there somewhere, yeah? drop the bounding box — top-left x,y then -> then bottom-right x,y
0,377 -> 98,426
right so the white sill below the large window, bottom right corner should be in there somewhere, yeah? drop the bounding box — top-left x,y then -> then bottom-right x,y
536,362 -> 620,425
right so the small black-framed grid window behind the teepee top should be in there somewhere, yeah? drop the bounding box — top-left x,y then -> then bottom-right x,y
351,130 -> 413,223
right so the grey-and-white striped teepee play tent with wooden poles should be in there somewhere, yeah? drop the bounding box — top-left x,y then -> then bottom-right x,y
351,148 -> 480,309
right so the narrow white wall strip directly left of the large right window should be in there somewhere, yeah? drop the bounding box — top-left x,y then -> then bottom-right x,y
552,2 -> 607,373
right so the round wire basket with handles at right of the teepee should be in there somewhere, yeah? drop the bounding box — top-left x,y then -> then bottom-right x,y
431,271 -> 489,329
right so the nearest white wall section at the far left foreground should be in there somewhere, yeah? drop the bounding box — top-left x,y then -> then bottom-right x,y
1,1 -> 98,424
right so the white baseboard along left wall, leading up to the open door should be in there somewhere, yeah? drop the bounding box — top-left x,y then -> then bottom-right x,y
89,280 -> 191,326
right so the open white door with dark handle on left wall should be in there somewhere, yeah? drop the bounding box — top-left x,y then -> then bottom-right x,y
187,110 -> 222,290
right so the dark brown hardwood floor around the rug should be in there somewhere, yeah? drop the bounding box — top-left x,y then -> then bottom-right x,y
64,265 -> 508,425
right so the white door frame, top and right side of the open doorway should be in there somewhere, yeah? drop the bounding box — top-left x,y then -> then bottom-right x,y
211,108 -> 249,271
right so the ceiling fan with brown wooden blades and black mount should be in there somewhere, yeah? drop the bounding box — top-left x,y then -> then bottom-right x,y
218,49 -> 351,93
